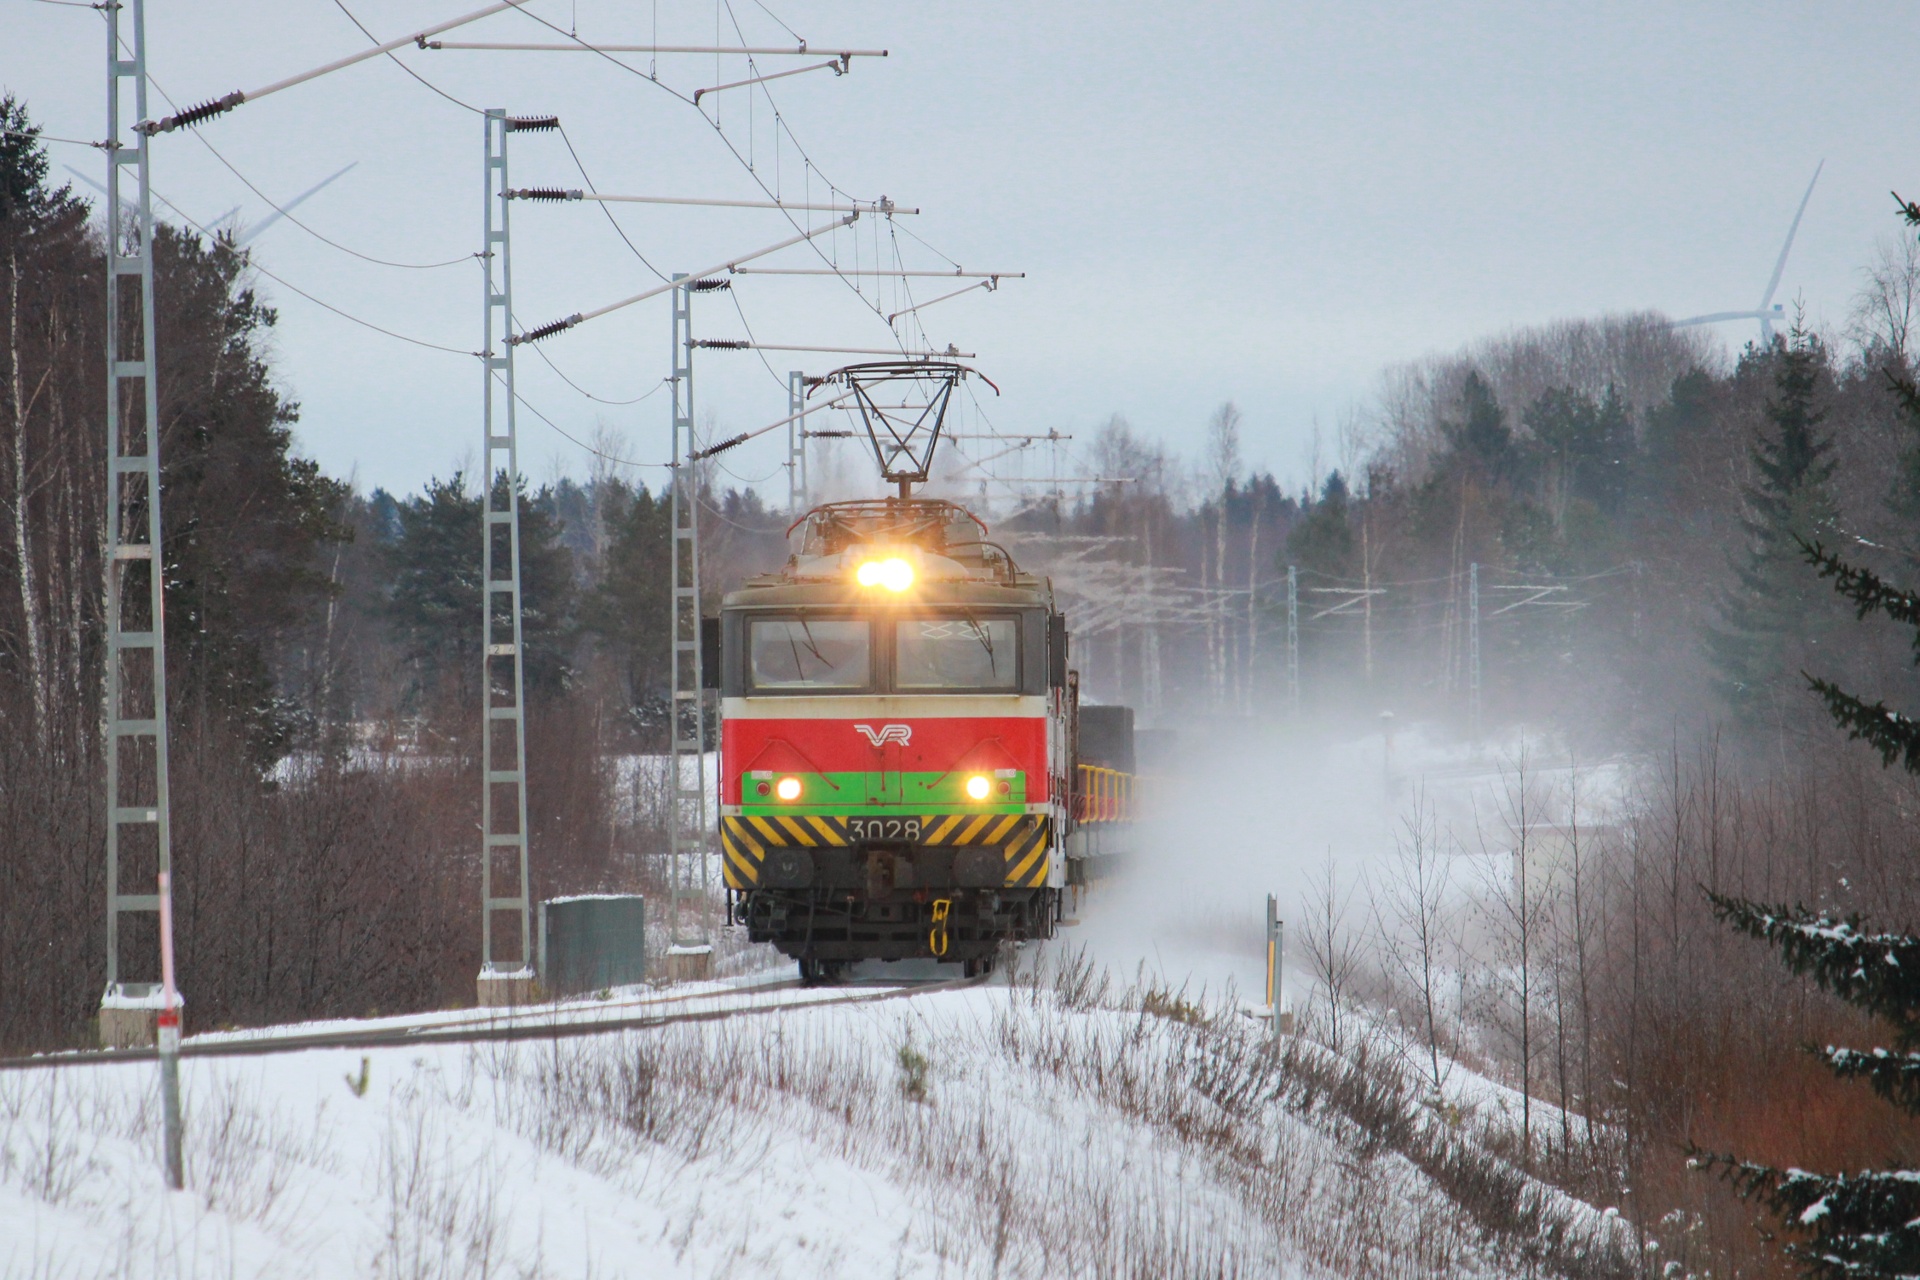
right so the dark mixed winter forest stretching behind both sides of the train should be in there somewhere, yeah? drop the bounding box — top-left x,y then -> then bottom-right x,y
0,100 -> 1920,1274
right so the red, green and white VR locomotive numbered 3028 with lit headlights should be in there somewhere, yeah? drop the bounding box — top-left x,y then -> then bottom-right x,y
716,498 -> 1077,983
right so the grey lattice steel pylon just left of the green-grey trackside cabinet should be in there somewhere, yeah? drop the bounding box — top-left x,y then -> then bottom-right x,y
478,107 -> 551,1004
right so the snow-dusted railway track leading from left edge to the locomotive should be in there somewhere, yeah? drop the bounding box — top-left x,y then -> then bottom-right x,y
0,977 -> 987,1071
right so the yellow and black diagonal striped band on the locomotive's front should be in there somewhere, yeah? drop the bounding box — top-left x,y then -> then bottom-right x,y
720,814 -> 1052,889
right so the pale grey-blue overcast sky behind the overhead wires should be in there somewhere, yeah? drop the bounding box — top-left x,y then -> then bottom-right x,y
0,0 -> 1920,499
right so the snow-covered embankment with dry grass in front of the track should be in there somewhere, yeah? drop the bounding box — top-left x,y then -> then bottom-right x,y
0,963 -> 1615,1276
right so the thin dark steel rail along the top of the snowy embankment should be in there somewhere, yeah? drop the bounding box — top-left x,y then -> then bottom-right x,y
0,977 -> 987,1071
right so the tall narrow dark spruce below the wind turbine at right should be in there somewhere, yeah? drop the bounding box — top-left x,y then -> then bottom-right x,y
1709,326 -> 1837,722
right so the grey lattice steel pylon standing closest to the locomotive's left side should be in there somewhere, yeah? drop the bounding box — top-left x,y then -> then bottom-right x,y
666,274 -> 726,979
